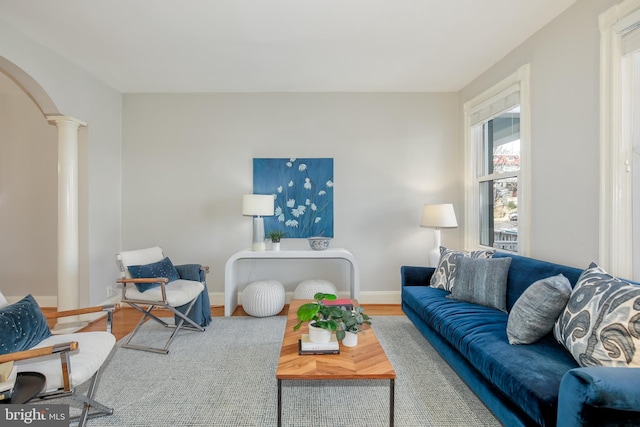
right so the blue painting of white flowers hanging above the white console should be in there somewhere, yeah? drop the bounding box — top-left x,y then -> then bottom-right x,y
253,158 -> 334,238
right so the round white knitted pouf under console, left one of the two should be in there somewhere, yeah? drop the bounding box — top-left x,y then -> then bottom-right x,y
242,280 -> 285,317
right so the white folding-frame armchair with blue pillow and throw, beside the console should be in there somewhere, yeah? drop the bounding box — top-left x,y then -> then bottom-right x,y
116,246 -> 211,354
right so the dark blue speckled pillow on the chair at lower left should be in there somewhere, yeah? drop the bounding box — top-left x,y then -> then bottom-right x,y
0,294 -> 52,354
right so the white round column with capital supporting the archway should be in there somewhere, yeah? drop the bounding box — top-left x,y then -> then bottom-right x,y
47,116 -> 87,330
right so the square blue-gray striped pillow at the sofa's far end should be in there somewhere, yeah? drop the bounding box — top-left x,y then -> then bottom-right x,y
450,257 -> 511,312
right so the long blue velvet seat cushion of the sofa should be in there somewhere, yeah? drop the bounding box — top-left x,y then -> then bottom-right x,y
403,284 -> 578,425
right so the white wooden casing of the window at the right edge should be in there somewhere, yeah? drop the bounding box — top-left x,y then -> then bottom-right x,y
598,0 -> 640,277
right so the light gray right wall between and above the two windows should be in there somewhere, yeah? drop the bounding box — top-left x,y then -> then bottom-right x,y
459,0 -> 617,268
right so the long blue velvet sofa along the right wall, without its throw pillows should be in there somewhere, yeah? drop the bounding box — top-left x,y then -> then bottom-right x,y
401,252 -> 640,427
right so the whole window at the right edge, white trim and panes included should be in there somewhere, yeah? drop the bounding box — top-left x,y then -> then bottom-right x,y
598,0 -> 640,280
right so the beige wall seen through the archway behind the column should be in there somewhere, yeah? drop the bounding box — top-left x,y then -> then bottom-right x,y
0,73 -> 58,295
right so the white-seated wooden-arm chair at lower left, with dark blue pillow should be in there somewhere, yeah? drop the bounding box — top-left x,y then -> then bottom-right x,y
0,293 -> 117,426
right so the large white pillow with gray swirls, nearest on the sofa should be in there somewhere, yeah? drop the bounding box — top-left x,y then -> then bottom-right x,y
553,263 -> 640,367
